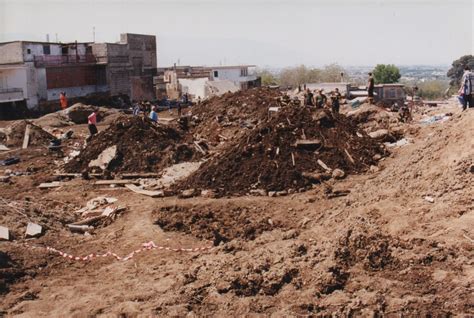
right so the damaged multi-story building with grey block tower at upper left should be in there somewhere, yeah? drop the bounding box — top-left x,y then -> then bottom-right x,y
0,33 -> 157,109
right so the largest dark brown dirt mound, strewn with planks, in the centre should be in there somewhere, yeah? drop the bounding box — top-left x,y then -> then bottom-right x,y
180,107 -> 385,194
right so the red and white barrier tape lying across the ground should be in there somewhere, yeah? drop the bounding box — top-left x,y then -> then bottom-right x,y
20,241 -> 213,261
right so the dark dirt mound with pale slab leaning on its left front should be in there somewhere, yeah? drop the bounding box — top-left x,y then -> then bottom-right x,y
64,116 -> 199,172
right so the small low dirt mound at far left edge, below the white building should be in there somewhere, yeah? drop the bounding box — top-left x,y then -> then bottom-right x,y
0,120 -> 55,147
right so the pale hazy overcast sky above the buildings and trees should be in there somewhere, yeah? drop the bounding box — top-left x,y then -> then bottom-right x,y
0,0 -> 474,67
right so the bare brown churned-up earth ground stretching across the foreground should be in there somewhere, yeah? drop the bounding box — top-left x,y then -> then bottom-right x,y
0,99 -> 474,317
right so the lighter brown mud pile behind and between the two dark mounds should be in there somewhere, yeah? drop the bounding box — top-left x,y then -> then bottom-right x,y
192,87 -> 280,142
